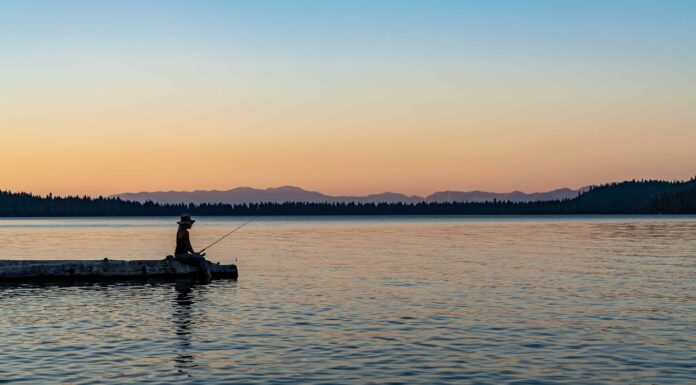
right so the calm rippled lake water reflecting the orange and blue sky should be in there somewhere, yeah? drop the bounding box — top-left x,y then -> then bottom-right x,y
0,217 -> 696,385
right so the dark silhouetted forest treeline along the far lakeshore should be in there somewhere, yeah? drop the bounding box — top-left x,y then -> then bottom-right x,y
0,178 -> 696,217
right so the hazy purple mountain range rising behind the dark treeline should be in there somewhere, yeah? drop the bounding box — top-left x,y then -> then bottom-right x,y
112,186 -> 584,204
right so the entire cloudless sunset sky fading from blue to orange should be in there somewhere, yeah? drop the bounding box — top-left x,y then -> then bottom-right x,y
0,0 -> 696,195
